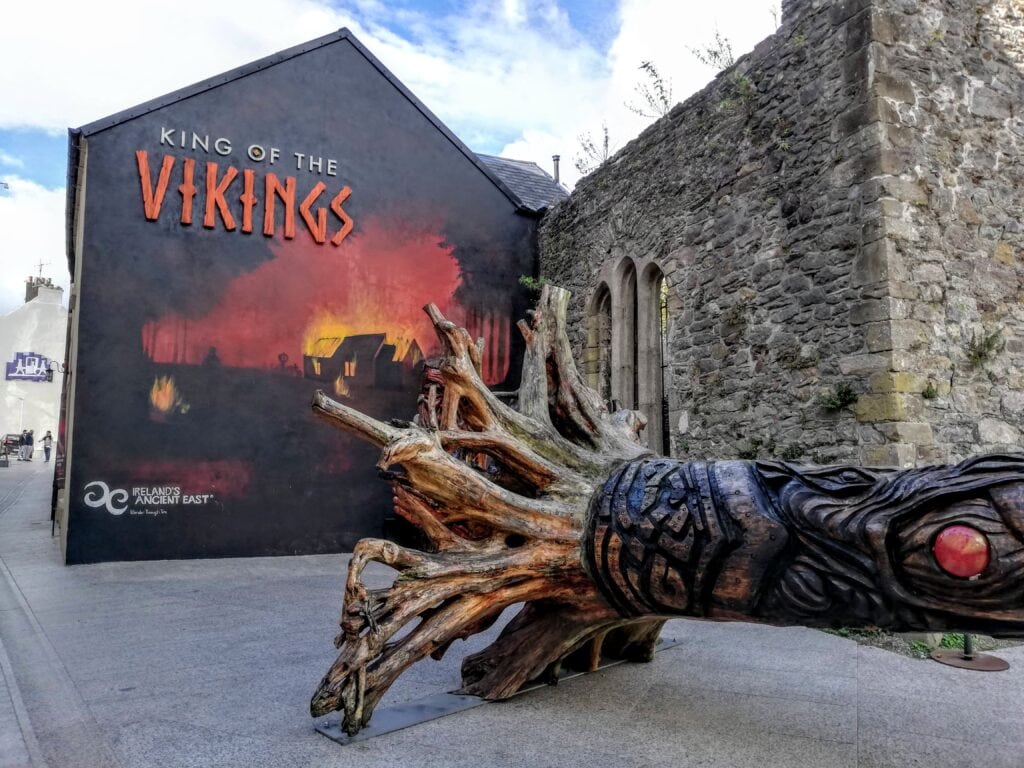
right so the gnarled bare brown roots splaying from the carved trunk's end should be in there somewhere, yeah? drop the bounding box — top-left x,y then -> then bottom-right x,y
310,287 -> 660,733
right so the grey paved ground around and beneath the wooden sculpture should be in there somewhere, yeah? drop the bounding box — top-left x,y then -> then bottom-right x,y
0,462 -> 1024,768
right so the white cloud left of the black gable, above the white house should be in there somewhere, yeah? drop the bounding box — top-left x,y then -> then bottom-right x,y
0,175 -> 68,314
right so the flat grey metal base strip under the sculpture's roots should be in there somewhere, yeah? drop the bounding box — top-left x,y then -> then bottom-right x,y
314,638 -> 682,744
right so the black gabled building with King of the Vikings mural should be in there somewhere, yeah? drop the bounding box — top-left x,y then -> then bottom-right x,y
61,30 -> 563,563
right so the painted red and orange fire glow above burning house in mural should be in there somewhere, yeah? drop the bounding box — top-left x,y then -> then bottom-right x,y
141,221 -> 510,387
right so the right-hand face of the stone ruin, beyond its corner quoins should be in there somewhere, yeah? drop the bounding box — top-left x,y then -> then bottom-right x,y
873,0 -> 1024,463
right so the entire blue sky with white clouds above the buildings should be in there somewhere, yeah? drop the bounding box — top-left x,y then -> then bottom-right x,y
0,0 -> 779,315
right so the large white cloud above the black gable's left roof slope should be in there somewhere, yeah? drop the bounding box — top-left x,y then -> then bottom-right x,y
0,0 -> 356,132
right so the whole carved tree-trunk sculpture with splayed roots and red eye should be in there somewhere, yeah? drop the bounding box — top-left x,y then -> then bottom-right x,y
310,287 -> 1024,733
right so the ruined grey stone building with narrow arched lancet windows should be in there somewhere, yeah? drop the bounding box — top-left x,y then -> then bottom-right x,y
540,0 -> 1024,466
